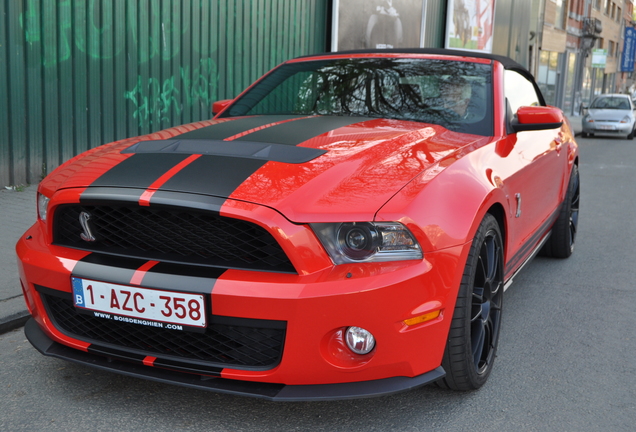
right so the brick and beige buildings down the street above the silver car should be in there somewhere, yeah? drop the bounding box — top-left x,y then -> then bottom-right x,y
534,0 -> 633,115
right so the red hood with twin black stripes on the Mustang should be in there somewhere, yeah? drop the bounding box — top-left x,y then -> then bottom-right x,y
45,116 -> 488,222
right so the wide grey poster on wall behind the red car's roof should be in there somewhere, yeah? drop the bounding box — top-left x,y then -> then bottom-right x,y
331,0 -> 426,51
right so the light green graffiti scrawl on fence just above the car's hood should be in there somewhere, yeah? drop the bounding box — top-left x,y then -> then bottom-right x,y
124,58 -> 218,128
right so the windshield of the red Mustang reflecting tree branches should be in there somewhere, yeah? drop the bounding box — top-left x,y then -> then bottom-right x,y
223,58 -> 493,136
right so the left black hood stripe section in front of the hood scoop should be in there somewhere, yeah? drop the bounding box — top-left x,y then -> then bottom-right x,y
91,153 -> 188,189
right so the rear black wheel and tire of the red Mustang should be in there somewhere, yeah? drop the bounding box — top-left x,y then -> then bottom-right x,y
544,165 -> 581,258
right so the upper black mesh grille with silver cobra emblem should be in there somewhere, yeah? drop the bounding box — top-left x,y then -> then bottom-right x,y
53,205 -> 295,273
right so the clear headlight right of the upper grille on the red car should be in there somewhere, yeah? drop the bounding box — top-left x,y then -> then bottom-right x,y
311,222 -> 422,264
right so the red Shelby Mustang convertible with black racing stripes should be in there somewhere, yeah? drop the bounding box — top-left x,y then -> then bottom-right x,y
17,49 -> 579,400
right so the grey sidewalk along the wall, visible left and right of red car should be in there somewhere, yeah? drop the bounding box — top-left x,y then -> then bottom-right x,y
0,116 -> 582,334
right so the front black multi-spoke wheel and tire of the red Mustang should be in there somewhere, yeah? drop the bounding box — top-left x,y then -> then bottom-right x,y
438,214 -> 504,391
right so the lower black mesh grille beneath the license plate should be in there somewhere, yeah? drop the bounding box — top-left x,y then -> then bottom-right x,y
40,290 -> 286,370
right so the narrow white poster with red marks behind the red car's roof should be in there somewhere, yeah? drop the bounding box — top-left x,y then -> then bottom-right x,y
445,0 -> 495,53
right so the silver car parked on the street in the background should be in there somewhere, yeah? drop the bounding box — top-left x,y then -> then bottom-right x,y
582,94 -> 636,140
